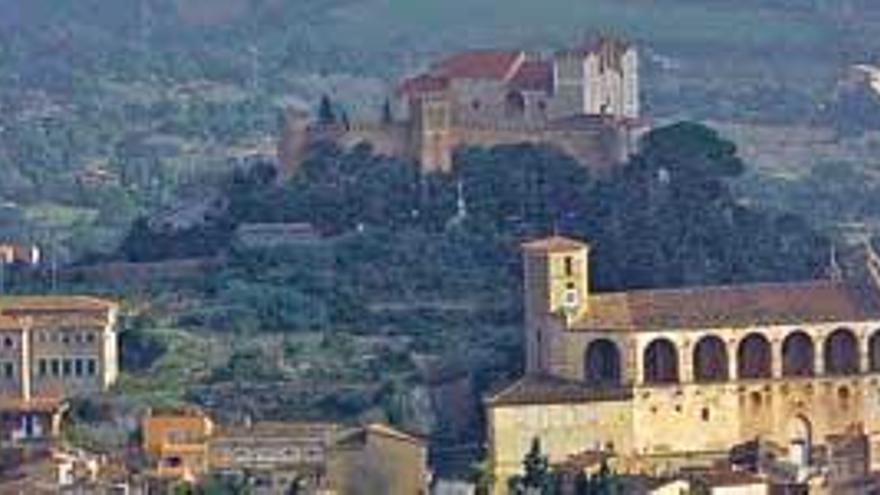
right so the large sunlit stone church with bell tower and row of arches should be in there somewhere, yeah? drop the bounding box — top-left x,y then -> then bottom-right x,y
487,237 -> 880,492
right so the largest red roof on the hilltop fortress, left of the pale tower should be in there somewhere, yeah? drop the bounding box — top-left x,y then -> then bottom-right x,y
431,50 -> 525,80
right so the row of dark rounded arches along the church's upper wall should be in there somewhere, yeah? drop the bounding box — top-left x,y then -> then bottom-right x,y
583,327 -> 880,386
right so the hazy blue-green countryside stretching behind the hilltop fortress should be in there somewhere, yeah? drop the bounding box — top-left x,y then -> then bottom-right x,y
0,0 -> 880,262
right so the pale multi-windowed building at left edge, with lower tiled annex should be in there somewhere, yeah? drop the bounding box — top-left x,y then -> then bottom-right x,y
0,296 -> 119,441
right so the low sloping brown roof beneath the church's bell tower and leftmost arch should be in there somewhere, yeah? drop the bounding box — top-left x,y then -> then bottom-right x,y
487,376 -> 632,407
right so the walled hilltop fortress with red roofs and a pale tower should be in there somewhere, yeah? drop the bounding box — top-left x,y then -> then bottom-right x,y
278,38 -> 644,173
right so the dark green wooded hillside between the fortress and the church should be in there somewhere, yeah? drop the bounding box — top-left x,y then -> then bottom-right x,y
98,123 -> 829,438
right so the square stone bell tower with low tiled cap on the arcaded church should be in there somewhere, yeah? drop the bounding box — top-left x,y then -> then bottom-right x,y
523,236 -> 590,373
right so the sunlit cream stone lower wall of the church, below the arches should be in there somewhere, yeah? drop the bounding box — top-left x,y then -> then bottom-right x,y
487,374 -> 880,493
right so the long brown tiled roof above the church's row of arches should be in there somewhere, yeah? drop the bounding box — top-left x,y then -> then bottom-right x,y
572,281 -> 880,330
